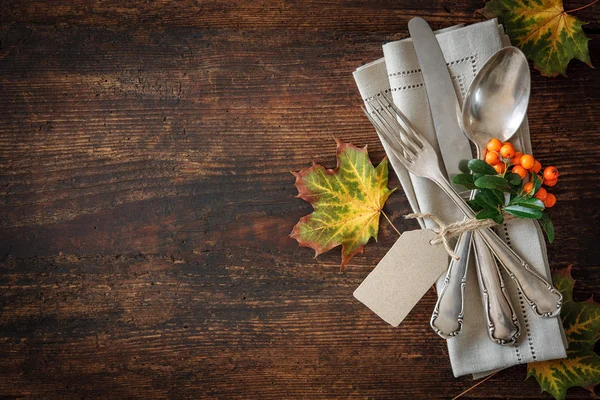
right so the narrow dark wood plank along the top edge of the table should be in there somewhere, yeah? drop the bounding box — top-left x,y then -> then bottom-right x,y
0,0 -> 600,33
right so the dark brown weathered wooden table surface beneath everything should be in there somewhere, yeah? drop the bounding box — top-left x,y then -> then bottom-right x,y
0,0 -> 600,399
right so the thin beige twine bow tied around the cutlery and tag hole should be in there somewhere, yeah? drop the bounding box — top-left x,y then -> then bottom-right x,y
404,213 -> 516,260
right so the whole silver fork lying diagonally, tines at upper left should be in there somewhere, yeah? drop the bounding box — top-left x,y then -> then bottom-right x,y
362,94 -> 562,318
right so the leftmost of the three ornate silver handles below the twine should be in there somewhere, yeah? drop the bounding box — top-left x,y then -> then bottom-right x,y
430,232 -> 472,339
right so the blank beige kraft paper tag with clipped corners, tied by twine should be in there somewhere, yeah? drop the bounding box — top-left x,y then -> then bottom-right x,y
354,229 -> 449,327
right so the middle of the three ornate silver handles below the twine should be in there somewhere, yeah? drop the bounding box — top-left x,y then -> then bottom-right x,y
474,234 -> 521,345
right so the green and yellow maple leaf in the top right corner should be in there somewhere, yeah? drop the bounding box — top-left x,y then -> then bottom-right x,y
479,0 -> 592,76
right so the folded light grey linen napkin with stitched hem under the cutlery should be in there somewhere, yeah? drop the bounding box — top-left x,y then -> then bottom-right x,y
354,19 -> 566,378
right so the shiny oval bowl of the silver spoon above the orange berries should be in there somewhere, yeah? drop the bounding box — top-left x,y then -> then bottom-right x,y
461,47 -> 531,150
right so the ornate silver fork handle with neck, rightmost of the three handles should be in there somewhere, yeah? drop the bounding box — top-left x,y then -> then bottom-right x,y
432,173 -> 562,317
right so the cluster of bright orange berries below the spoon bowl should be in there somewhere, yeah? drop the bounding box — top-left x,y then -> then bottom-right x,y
485,138 -> 558,208
